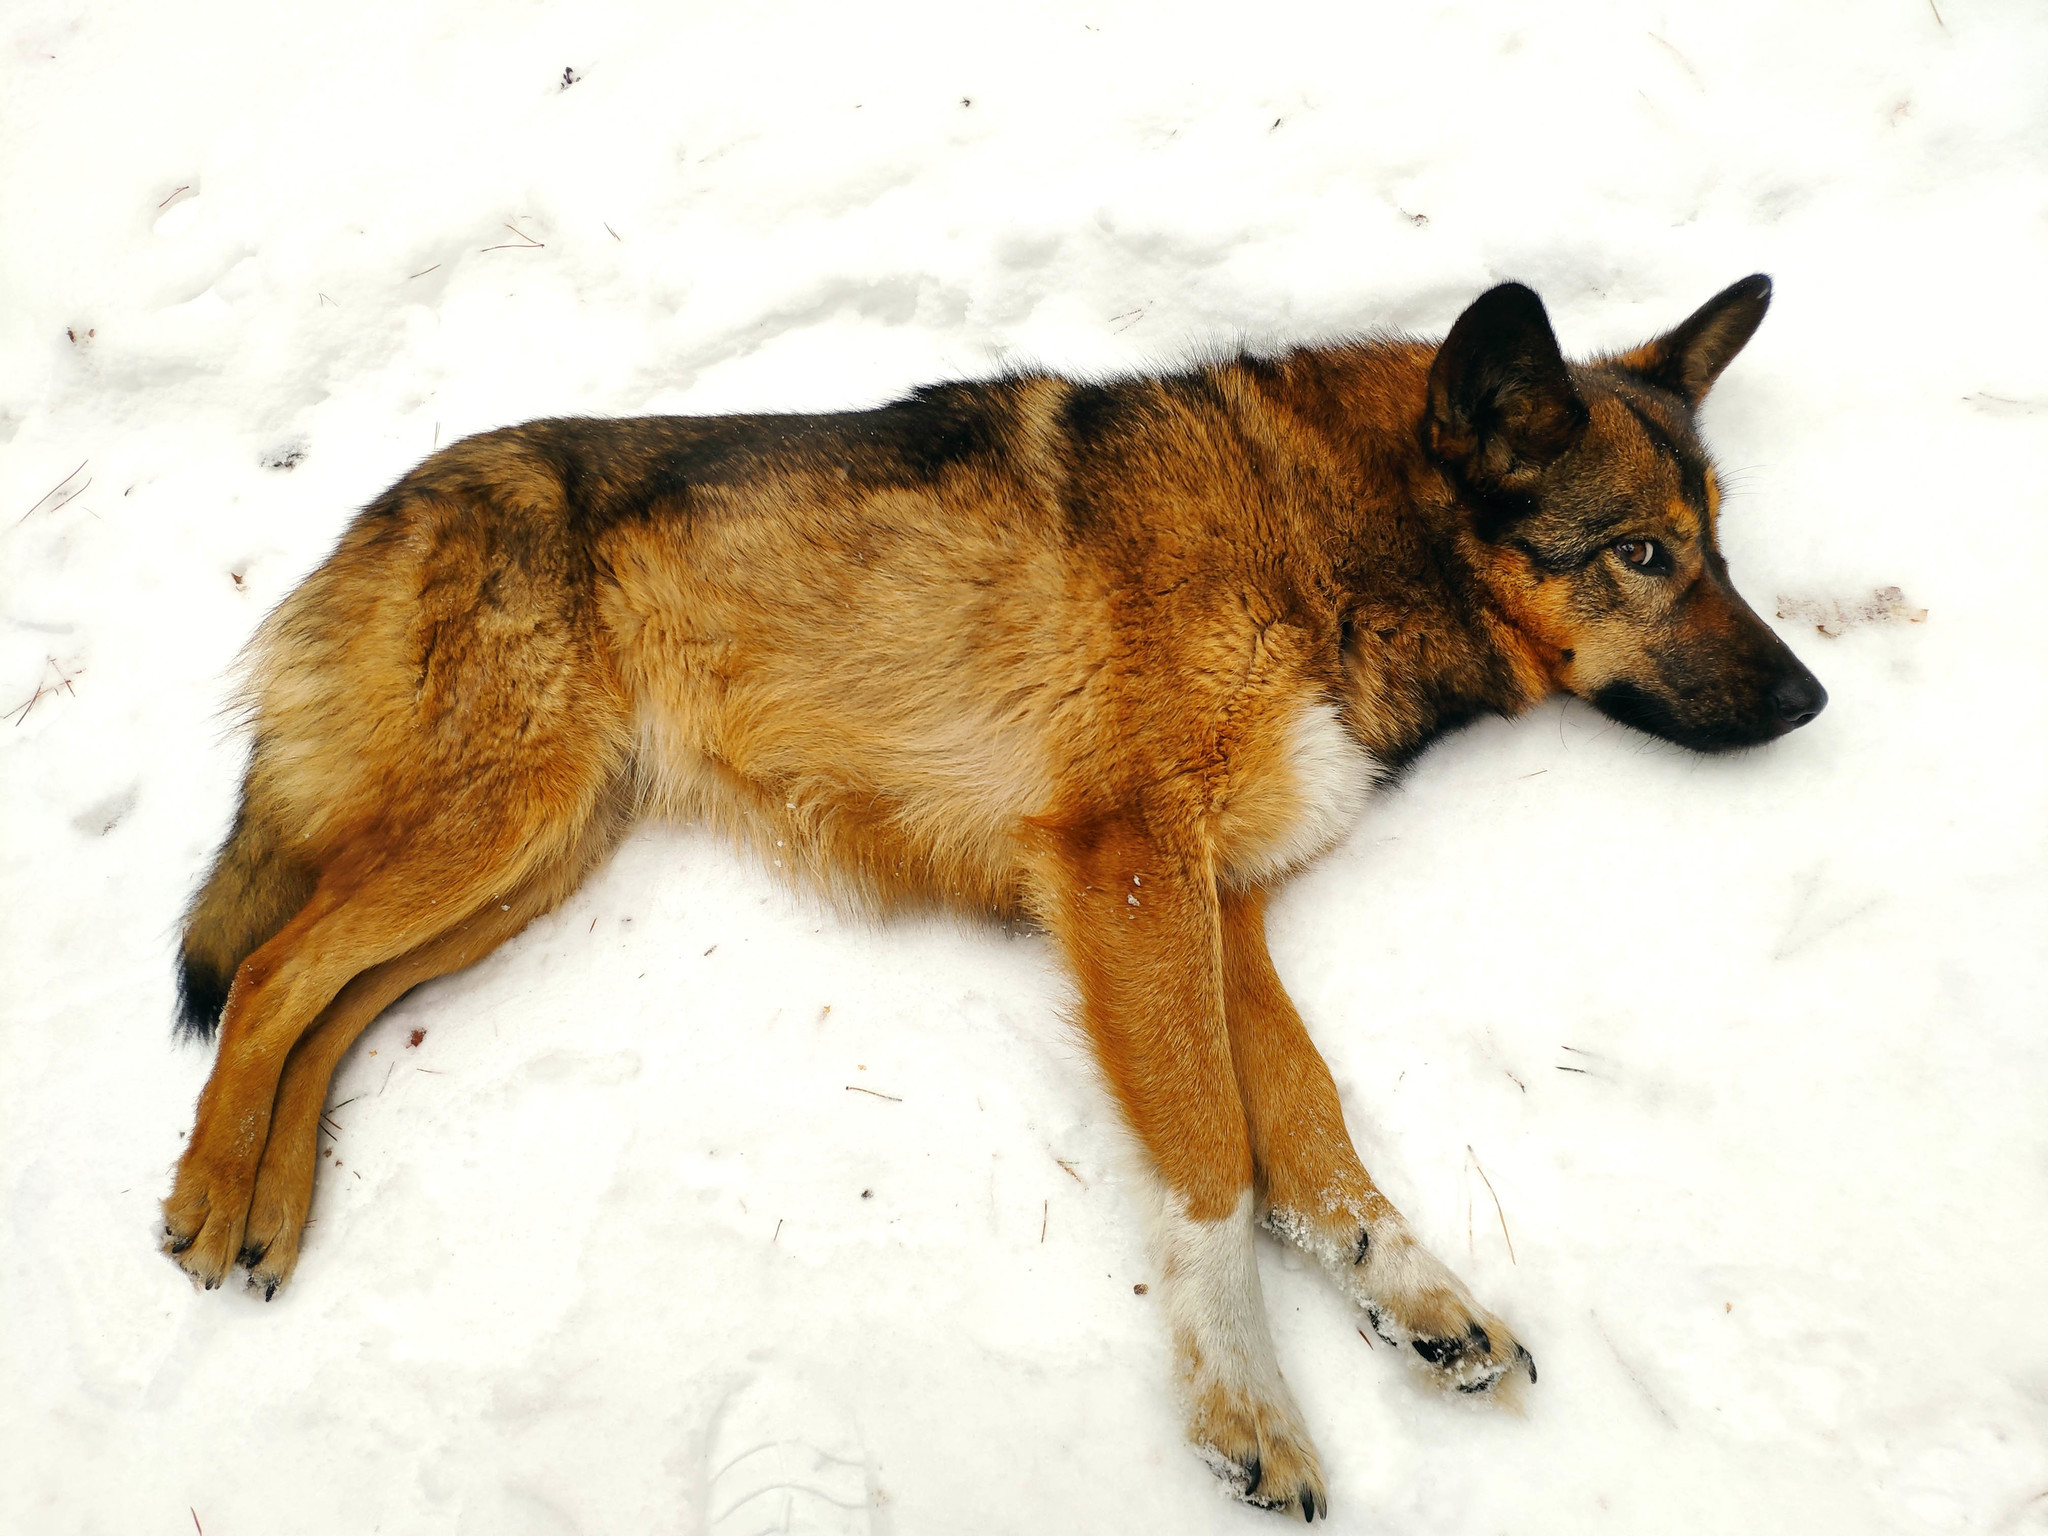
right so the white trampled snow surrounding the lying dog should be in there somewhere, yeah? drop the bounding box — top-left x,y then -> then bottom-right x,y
0,0 -> 2048,1536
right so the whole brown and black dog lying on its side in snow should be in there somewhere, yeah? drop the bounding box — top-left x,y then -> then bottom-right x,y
164,276 -> 1827,1520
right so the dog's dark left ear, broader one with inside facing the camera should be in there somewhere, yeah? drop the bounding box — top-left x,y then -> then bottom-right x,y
1425,283 -> 1585,492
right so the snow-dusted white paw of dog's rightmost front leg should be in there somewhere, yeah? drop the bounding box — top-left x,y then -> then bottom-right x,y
1358,1227 -> 1536,1393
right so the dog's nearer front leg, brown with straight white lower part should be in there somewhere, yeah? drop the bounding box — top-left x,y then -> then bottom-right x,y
1047,823 -> 1329,1520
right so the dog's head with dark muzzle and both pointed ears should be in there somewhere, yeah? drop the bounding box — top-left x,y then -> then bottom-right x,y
1423,276 -> 1827,752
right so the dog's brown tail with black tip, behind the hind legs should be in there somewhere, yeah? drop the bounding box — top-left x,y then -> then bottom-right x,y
178,772 -> 315,1040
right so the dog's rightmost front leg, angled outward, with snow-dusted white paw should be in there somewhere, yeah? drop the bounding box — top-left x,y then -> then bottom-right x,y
1223,891 -> 1536,1393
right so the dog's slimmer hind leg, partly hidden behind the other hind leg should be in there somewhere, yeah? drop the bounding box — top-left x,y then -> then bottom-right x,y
240,798 -> 623,1300
